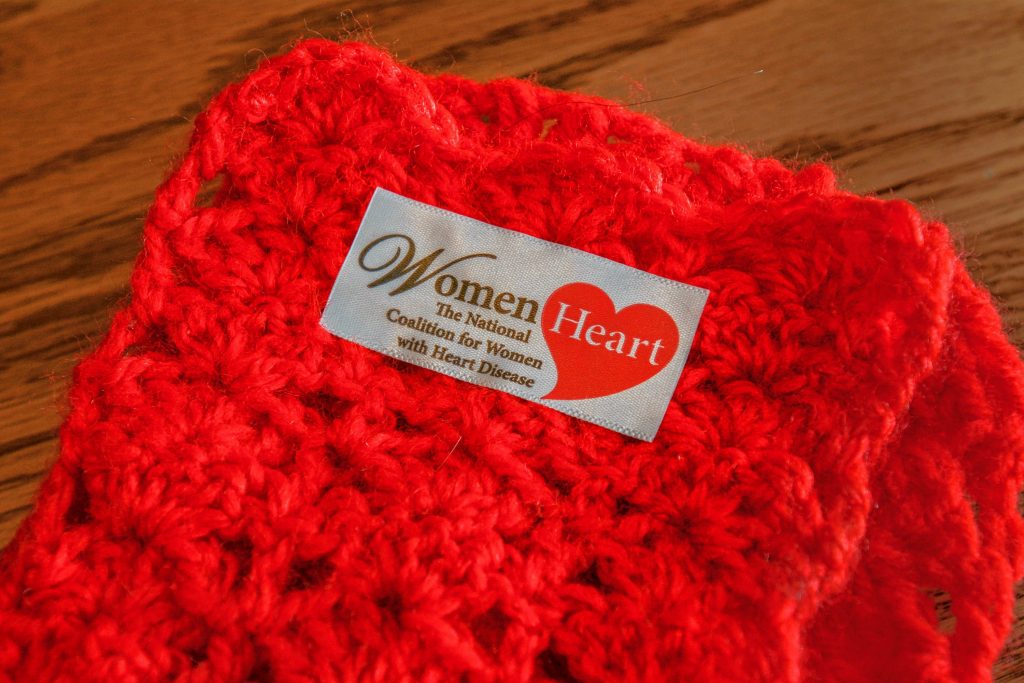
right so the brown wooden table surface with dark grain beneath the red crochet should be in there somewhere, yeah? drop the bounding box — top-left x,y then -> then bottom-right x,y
0,0 -> 1024,681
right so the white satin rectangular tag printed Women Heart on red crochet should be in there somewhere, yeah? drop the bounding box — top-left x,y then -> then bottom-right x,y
321,187 -> 708,441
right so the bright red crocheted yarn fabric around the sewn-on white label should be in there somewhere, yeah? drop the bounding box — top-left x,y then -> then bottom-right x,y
0,40 -> 1024,682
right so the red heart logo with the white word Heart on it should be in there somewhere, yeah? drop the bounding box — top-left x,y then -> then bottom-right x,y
541,283 -> 679,399
